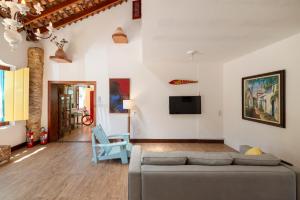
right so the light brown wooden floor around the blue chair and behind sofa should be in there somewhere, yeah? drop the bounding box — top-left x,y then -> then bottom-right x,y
0,143 -> 232,200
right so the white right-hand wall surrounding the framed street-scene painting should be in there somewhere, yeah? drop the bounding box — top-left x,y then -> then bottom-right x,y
223,34 -> 300,166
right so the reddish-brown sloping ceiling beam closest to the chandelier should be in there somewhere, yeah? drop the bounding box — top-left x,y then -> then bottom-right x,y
25,0 -> 81,25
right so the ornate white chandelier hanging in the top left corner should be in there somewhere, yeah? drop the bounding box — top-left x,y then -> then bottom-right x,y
0,0 -> 54,50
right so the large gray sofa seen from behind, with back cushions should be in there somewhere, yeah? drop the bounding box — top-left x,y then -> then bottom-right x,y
128,146 -> 300,200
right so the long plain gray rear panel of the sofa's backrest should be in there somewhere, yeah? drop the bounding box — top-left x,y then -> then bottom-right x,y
141,165 -> 296,200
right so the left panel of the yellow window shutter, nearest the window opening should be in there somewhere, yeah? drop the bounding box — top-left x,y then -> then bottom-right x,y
4,71 -> 15,121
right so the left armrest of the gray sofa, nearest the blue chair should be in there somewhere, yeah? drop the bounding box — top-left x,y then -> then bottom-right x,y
128,145 -> 142,200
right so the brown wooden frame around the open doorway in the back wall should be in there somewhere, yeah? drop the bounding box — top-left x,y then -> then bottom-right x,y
48,81 -> 97,142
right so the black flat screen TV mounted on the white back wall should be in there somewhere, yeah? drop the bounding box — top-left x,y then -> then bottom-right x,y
169,96 -> 201,114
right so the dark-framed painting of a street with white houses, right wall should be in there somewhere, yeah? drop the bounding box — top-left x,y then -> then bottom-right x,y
242,70 -> 285,128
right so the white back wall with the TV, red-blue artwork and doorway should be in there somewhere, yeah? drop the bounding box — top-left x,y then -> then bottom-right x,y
42,1 -> 222,139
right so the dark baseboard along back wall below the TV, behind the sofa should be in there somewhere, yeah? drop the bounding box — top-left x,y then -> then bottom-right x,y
130,139 -> 224,144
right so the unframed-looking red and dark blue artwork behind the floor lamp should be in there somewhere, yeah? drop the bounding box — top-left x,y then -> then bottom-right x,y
109,78 -> 130,113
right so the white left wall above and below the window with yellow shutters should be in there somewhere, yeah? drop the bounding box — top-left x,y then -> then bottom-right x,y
0,25 -> 38,146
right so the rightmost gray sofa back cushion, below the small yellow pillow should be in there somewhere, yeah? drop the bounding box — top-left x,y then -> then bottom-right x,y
230,153 -> 281,166
